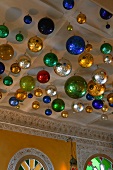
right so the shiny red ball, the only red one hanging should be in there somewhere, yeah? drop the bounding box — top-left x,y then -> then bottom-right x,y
37,70 -> 50,83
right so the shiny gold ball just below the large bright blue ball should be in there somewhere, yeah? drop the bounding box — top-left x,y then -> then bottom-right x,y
78,52 -> 94,68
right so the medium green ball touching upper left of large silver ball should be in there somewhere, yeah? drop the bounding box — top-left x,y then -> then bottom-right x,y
43,53 -> 58,67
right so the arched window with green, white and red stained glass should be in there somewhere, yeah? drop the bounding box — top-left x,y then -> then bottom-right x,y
84,155 -> 113,170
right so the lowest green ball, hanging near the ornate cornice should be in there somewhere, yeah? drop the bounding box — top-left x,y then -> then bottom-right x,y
51,98 -> 65,112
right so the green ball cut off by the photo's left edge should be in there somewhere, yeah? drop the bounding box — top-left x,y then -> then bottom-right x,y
0,25 -> 9,38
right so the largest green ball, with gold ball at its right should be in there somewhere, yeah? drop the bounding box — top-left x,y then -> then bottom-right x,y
64,76 -> 88,99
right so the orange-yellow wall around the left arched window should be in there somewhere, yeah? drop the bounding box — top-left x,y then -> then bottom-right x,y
0,130 -> 75,170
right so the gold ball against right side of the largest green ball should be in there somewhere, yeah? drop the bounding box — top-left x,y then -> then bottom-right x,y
88,80 -> 106,96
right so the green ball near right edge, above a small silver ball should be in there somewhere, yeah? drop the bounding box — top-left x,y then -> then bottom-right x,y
100,43 -> 112,54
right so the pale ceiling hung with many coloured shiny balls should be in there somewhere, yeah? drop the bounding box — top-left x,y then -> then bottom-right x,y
0,0 -> 113,133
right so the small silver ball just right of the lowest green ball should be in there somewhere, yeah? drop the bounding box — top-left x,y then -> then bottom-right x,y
72,101 -> 84,112
